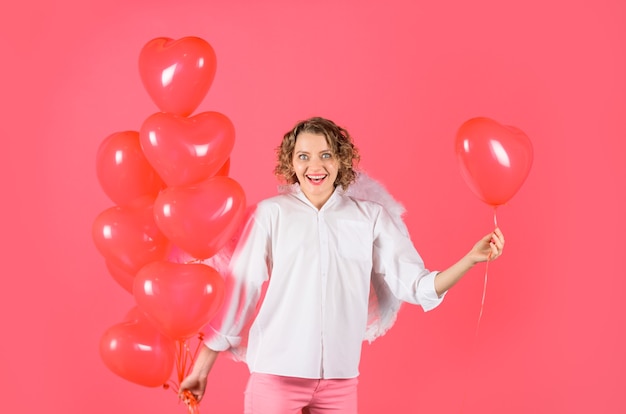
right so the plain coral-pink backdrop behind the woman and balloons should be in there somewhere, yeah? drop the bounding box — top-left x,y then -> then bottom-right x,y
0,0 -> 626,414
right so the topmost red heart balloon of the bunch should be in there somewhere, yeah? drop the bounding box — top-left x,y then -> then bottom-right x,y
139,37 -> 216,116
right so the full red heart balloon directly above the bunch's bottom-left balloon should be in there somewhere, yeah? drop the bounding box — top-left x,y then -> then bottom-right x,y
133,261 -> 224,340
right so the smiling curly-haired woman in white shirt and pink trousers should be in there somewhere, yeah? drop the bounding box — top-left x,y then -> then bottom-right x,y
180,118 -> 504,414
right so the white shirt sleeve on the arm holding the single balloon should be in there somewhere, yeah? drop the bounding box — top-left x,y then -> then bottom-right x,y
373,205 -> 445,311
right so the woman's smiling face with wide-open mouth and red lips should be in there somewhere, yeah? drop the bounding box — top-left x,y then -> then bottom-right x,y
293,132 -> 339,209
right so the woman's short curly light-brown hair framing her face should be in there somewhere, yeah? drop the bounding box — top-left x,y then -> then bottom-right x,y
274,117 -> 360,190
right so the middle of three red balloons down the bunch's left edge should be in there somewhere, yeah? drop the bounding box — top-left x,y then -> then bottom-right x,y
92,197 -> 169,275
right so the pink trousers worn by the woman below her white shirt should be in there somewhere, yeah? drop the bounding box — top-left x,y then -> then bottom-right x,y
244,373 -> 358,414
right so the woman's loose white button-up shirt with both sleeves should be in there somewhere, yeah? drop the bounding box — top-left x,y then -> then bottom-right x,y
206,190 -> 442,378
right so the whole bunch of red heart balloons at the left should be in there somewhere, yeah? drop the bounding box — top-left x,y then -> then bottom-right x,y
92,37 -> 246,387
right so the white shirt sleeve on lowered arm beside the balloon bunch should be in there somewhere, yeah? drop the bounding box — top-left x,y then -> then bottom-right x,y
205,208 -> 271,351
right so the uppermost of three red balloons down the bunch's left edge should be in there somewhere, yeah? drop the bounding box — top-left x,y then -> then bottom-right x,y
96,131 -> 165,206
